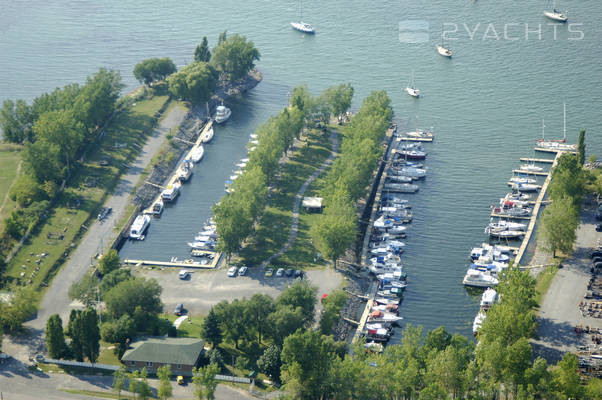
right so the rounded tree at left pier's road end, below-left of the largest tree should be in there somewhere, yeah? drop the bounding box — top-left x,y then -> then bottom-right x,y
167,62 -> 217,104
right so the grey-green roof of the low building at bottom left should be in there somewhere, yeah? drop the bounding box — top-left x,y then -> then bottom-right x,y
121,337 -> 204,365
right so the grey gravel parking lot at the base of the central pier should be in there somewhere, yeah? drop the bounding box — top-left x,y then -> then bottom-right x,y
132,267 -> 344,315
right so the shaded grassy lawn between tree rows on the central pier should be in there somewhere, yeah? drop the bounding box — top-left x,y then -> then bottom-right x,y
240,131 -> 331,269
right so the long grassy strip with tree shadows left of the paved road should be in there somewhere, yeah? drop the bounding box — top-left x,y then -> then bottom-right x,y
5,96 -> 168,288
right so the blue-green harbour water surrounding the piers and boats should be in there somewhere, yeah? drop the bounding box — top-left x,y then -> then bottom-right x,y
0,0 -> 602,335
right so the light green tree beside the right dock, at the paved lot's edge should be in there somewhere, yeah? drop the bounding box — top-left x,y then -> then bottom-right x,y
539,197 -> 579,257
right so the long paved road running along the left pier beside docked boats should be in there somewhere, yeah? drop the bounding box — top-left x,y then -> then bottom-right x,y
4,107 -> 187,360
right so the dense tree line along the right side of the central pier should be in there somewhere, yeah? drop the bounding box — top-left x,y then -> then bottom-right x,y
310,91 -> 393,268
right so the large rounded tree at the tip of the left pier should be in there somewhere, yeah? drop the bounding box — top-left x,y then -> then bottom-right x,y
211,35 -> 260,82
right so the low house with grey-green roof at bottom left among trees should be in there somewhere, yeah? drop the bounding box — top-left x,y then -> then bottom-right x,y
121,337 -> 204,376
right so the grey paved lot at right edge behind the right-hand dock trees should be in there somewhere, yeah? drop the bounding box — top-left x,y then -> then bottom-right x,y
533,202 -> 602,362
